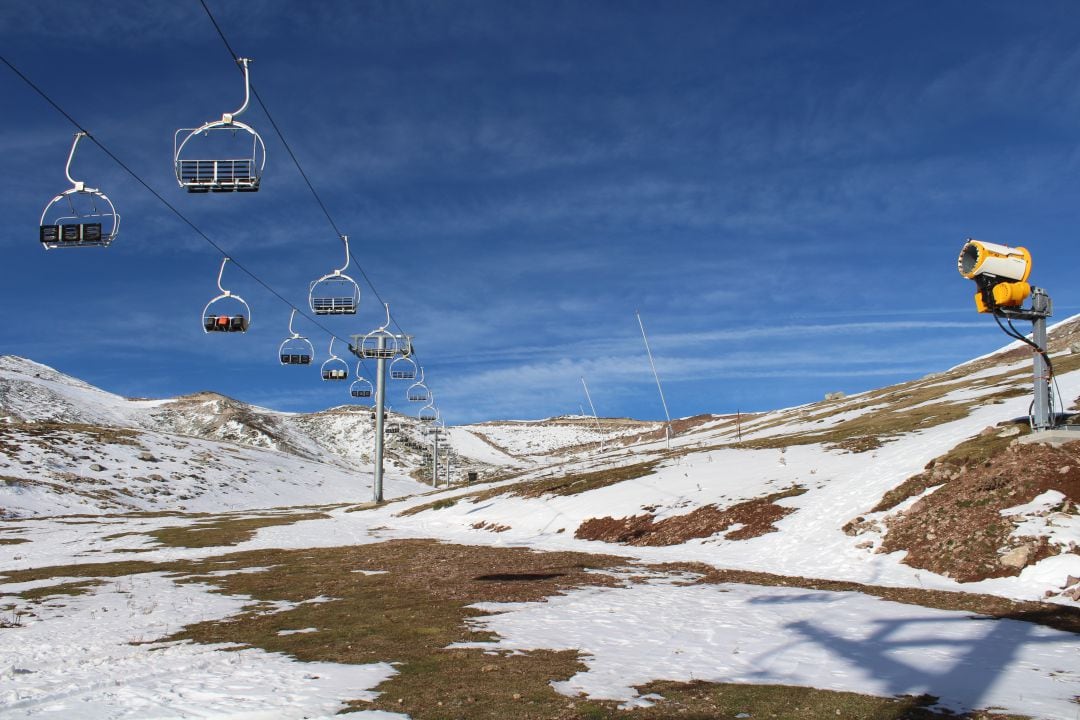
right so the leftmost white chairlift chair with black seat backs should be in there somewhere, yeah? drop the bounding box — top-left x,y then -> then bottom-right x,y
38,132 -> 120,250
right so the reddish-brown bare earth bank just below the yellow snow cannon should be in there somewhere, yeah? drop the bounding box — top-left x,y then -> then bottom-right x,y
876,443 -> 1080,582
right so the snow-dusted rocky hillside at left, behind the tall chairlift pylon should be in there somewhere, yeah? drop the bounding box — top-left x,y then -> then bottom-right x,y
0,356 -> 428,517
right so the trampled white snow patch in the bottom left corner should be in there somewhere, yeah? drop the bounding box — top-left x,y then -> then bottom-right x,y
0,573 -> 395,720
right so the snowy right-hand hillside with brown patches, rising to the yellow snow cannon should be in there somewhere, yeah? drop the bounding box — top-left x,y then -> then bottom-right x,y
386,318 -> 1080,603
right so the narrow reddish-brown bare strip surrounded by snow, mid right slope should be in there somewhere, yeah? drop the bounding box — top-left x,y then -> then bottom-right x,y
573,488 -> 806,546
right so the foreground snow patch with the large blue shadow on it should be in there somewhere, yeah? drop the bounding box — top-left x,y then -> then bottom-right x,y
457,580 -> 1080,718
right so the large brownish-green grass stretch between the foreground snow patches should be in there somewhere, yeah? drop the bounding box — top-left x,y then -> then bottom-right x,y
5,541 -> 1058,720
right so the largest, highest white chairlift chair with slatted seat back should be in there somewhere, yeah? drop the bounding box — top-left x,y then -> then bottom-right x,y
173,57 -> 267,192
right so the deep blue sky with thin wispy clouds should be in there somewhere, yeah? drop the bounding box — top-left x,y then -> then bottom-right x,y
0,0 -> 1080,422
